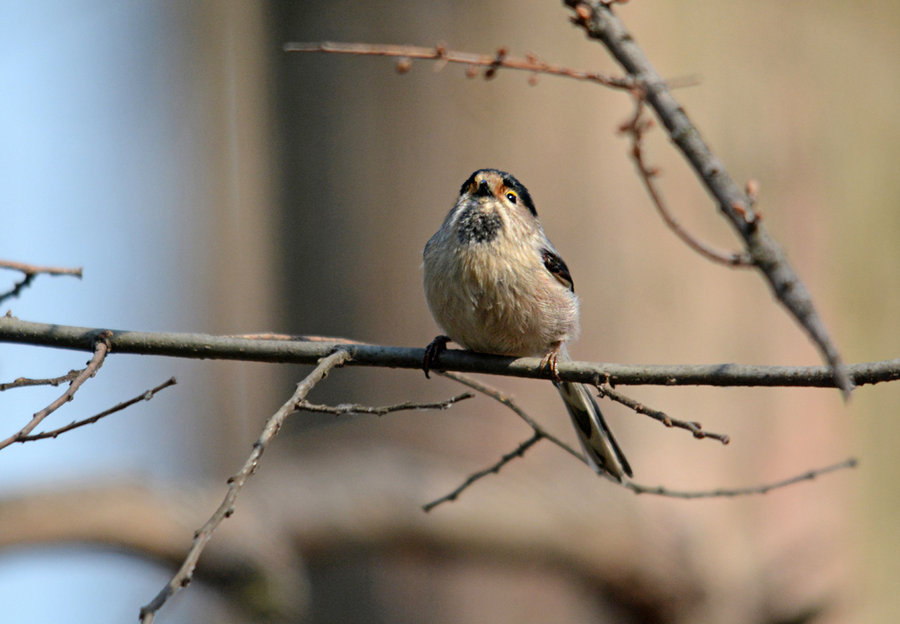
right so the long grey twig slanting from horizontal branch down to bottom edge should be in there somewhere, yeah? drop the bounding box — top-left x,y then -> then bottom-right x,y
140,350 -> 350,624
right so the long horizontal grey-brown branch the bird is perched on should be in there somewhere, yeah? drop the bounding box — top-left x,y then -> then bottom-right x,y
0,316 -> 900,388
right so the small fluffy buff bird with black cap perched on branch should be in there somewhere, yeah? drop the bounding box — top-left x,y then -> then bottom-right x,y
423,169 -> 632,482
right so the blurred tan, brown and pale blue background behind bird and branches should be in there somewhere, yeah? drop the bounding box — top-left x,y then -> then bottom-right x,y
0,0 -> 900,623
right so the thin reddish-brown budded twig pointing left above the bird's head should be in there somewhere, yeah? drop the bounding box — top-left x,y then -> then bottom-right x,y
284,41 -> 633,89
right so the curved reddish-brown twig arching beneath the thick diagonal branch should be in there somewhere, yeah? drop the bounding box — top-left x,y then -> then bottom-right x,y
619,95 -> 753,267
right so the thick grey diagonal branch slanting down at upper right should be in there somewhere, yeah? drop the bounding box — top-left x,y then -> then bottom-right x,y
565,0 -> 854,398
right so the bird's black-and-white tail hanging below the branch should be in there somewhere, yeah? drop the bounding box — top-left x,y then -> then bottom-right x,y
556,381 -> 632,483
